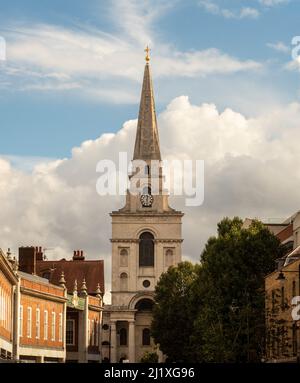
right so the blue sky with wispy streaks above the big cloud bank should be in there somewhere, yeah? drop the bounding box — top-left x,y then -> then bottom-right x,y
0,0 -> 300,158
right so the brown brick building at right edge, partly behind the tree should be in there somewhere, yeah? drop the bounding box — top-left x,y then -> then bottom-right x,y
265,212 -> 300,363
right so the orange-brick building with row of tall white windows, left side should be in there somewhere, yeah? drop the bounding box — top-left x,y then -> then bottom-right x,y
15,271 -> 67,363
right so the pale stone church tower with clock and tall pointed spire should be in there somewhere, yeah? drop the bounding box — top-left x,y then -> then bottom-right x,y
105,48 -> 183,362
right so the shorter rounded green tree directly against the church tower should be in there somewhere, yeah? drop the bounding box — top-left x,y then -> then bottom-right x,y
151,262 -> 199,362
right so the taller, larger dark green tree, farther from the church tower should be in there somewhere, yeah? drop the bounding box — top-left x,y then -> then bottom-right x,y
192,217 -> 280,362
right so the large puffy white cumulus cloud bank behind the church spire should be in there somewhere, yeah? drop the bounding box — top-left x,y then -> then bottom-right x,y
0,96 -> 300,304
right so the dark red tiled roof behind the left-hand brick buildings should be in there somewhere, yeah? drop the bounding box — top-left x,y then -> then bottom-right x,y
36,259 -> 104,295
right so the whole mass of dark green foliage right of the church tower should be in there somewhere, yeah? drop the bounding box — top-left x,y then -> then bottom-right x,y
152,217 -> 280,362
